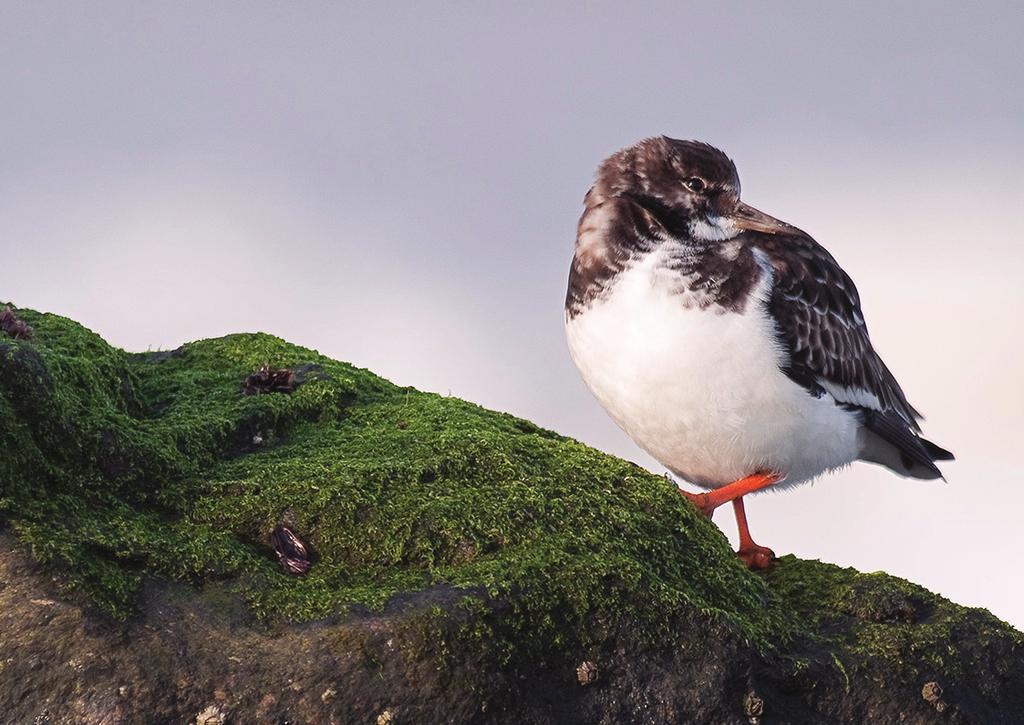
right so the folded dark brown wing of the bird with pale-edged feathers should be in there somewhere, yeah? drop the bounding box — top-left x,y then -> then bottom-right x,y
750,229 -> 952,473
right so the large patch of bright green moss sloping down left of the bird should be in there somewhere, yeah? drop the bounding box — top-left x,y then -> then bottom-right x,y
0,303 -> 785,646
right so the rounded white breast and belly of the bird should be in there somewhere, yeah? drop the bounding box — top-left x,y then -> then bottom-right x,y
566,246 -> 858,487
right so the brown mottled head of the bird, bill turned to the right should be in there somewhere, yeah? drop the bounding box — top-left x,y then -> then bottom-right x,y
593,136 -> 792,242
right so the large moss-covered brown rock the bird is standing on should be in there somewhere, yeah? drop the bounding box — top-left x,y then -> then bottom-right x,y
0,309 -> 1024,722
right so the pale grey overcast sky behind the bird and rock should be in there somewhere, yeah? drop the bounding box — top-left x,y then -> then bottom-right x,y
0,2 -> 1024,627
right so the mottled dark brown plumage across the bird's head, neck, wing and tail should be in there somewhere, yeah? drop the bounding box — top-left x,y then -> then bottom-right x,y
565,136 -> 951,487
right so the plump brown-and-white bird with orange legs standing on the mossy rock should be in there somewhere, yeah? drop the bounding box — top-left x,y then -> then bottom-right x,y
565,136 -> 953,568
